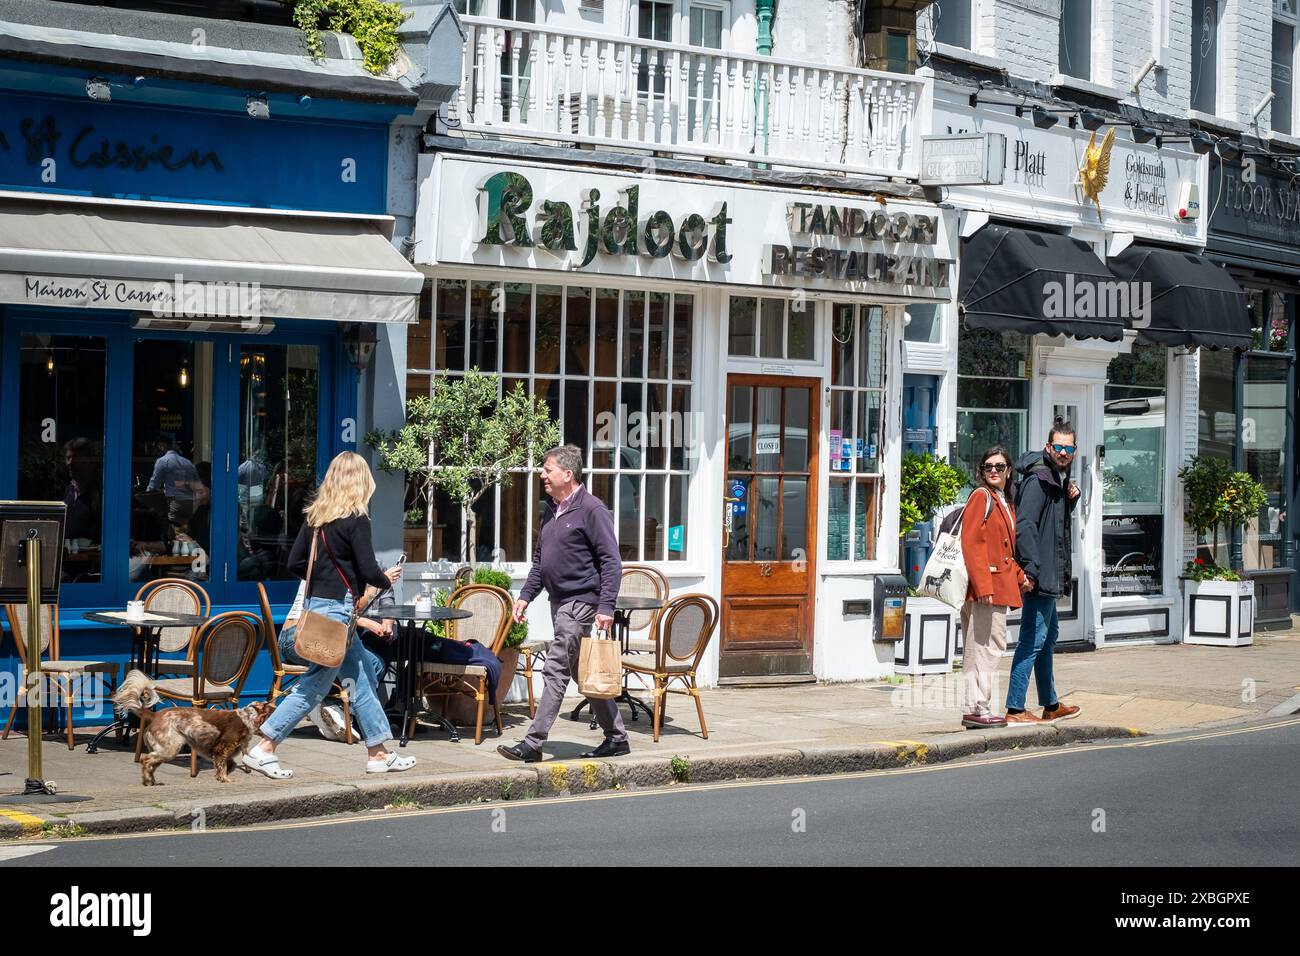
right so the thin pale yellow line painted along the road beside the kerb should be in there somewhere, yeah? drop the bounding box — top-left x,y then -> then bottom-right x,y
0,718 -> 1300,845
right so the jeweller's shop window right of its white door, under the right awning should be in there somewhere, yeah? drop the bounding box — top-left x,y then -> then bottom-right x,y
1101,345 -> 1167,596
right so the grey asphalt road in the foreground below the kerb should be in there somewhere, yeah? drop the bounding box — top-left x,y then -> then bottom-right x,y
0,718 -> 1300,866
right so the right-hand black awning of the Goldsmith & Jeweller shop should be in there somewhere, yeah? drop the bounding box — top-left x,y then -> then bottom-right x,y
1110,243 -> 1252,349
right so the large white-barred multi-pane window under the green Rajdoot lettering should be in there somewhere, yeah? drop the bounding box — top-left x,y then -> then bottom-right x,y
418,280 -> 696,562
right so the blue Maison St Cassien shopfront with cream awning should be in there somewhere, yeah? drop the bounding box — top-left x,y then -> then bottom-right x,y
0,69 -> 421,721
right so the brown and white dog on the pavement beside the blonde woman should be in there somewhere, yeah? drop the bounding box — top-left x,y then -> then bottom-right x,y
113,671 -> 276,787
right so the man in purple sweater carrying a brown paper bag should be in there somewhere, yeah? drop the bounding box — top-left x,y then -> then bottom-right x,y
497,445 -> 632,763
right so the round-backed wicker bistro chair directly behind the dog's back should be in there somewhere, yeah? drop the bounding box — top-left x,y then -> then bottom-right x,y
135,611 -> 261,777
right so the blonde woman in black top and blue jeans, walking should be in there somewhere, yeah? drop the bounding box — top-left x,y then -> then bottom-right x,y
244,451 -> 415,780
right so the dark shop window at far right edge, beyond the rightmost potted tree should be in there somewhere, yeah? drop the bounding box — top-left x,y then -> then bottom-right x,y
1242,354 -> 1290,571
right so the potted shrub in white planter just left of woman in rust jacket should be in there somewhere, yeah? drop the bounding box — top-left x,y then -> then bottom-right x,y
894,451 -> 966,674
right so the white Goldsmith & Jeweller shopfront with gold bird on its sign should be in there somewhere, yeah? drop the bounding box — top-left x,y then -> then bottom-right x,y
920,83 -> 1209,648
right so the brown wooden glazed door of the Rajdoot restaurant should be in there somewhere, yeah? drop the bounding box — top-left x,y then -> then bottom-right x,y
719,375 -> 822,678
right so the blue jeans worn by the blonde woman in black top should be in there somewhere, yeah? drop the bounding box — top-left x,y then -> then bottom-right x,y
261,594 -> 391,747
